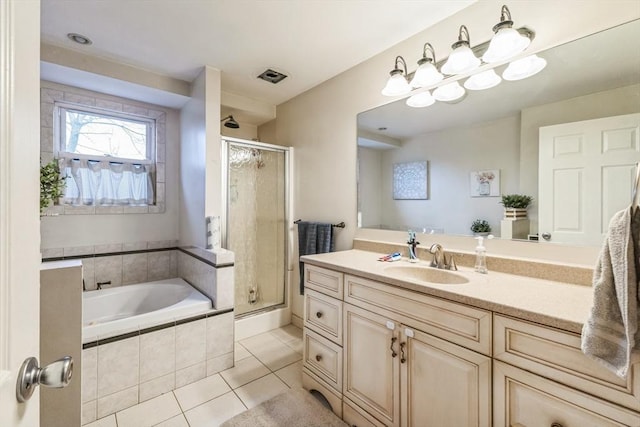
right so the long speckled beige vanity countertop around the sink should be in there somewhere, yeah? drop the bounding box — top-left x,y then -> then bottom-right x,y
300,249 -> 593,334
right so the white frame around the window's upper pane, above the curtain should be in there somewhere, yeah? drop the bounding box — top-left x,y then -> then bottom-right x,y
53,101 -> 158,166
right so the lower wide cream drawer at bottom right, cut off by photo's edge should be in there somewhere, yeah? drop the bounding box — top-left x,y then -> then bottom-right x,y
493,361 -> 640,427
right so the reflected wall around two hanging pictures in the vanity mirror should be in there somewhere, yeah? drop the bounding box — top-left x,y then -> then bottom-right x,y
360,116 -> 520,236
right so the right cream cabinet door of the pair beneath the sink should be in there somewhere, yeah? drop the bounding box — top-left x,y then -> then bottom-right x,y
399,326 -> 491,427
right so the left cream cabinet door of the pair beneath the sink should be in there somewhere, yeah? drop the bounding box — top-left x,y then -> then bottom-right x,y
343,304 -> 400,426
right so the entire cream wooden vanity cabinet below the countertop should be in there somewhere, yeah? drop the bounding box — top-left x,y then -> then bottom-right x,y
303,256 -> 640,427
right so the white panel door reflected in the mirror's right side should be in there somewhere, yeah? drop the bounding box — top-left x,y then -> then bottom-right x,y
538,114 -> 640,245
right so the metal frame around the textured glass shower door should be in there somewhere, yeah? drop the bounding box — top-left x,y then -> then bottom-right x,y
220,136 -> 293,319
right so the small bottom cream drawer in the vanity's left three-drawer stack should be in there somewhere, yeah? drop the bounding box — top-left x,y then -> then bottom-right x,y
303,328 -> 342,392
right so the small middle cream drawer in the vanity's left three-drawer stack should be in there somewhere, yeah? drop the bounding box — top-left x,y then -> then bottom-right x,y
304,289 -> 342,345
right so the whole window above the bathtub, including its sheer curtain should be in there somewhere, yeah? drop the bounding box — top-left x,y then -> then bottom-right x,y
54,103 -> 156,206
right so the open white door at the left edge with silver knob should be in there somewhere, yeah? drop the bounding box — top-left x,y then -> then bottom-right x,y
0,0 -> 40,427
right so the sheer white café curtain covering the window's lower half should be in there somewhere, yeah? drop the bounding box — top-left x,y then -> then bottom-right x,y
60,158 -> 154,206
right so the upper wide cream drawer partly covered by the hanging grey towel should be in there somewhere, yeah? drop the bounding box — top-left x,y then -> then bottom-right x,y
493,315 -> 640,410
